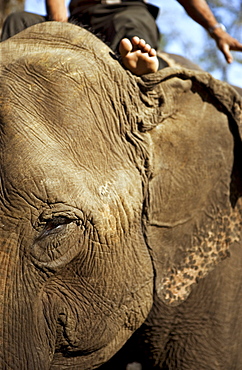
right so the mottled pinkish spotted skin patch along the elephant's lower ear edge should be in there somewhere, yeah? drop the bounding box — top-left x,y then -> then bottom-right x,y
160,202 -> 242,305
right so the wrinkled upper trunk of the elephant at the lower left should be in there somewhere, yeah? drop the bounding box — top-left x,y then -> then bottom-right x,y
0,233 -> 51,370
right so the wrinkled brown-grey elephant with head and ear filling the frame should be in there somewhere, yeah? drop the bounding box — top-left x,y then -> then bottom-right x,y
0,22 -> 242,370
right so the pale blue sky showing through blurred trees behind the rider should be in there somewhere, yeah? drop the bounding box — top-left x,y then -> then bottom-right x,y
25,0 -> 242,87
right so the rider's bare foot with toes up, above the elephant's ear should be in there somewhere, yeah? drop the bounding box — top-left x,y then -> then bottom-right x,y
119,36 -> 159,76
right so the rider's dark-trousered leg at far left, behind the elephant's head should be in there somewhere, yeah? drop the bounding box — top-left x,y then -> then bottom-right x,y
1,12 -> 47,41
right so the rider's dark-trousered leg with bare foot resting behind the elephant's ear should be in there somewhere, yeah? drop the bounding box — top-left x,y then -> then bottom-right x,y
70,1 -> 159,75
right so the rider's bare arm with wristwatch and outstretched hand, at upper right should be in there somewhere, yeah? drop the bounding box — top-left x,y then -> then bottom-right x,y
177,0 -> 242,63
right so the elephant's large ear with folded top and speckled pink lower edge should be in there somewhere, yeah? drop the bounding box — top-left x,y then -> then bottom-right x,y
142,68 -> 242,305
